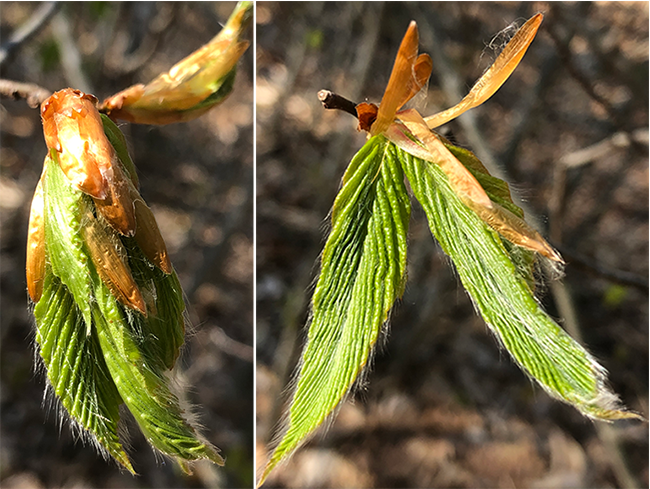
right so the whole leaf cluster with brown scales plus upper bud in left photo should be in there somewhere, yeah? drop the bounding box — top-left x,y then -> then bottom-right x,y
26,2 -> 253,473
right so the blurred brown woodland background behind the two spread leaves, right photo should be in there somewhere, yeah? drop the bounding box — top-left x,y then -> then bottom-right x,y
255,2 -> 649,489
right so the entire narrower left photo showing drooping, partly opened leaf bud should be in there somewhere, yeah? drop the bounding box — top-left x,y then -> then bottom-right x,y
0,2 -> 254,489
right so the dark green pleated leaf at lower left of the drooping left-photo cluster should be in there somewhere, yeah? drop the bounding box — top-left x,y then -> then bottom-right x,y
34,271 -> 135,473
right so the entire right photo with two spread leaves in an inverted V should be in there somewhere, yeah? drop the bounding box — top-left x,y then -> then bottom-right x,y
253,2 -> 649,489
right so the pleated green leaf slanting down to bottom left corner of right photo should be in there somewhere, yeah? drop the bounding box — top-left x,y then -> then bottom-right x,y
260,136 -> 410,484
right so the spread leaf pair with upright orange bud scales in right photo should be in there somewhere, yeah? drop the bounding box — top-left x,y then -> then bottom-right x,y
259,14 -> 636,485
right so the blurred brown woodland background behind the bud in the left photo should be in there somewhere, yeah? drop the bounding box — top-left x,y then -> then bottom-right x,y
0,2 -> 254,489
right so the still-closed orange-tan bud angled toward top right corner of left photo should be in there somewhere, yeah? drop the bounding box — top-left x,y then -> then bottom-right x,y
101,2 -> 253,124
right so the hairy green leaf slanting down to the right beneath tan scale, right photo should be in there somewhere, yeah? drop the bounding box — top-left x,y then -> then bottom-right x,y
397,149 -> 636,419
